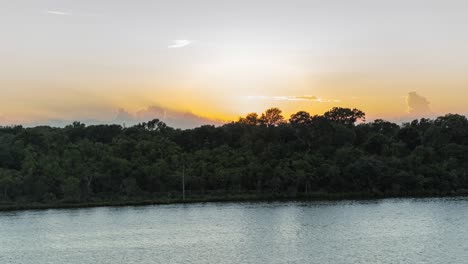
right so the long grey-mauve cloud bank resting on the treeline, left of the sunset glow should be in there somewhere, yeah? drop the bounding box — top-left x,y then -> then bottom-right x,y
112,106 -> 224,129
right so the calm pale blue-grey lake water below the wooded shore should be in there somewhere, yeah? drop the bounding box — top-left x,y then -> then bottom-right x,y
0,198 -> 468,264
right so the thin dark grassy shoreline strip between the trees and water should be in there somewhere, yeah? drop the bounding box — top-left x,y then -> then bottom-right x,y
0,191 -> 468,212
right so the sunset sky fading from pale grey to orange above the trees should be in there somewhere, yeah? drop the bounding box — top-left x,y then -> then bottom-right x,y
0,0 -> 468,128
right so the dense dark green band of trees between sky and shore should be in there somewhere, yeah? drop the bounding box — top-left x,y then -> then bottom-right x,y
0,108 -> 468,203
